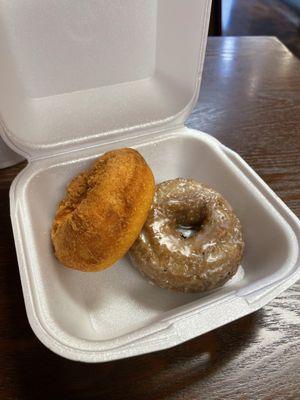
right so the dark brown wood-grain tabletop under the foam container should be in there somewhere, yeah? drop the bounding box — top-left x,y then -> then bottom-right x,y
0,37 -> 300,400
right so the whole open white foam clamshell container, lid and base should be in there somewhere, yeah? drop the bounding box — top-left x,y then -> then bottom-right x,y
0,0 -> 300,362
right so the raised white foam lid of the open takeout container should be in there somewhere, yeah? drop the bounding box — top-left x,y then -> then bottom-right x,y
0,0 -> 211,157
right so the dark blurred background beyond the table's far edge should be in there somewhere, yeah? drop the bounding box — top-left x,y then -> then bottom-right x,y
209,0 -> 300,58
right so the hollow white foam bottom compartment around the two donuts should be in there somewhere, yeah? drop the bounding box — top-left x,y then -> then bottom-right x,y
12,128 -> 298,357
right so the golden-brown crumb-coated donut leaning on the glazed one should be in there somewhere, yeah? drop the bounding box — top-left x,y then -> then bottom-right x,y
51,148 -> 155,271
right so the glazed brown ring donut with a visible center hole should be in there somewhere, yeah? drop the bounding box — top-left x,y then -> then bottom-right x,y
129,179 -> 244,292
